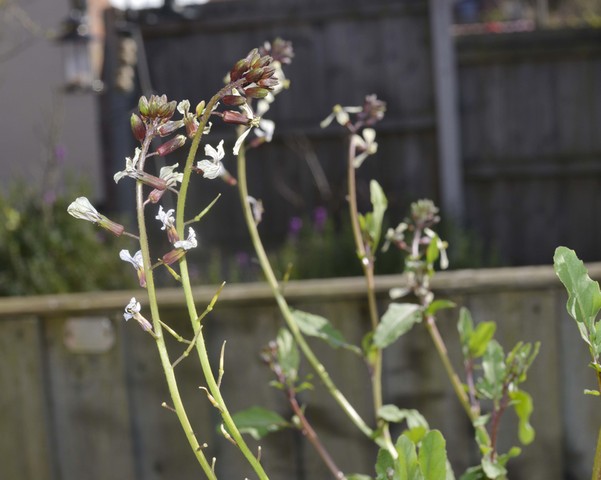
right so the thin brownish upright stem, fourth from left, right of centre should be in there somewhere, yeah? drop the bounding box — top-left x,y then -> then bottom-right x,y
347,139 -> 396,457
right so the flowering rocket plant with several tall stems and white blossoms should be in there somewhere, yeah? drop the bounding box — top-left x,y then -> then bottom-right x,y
68,39 -> 538,480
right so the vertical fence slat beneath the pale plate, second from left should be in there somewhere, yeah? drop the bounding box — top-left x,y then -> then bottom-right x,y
45,317 -> 135,480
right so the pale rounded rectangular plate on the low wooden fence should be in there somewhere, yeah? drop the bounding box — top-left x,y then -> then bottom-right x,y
63,317 -> 115,353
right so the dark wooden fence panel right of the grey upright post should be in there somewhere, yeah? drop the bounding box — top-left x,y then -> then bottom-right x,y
457,30 -> 601,264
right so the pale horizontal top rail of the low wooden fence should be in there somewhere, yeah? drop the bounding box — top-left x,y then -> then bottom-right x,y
0,263 -> 601,317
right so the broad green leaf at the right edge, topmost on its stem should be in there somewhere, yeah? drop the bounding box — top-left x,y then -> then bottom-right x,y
553,247 -> 601,331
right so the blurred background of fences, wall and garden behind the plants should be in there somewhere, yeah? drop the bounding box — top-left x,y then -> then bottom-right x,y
0,0 -> 601,480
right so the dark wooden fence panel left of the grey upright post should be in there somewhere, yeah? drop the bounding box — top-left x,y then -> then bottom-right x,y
113,0 -> 437,258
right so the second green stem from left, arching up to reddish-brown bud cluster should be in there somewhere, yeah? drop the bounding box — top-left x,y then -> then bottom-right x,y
175,90 -> 268,480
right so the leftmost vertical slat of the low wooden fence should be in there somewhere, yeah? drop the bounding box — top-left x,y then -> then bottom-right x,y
0,317 -> 56,480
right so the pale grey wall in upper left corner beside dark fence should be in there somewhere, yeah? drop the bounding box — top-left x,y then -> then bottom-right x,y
0,0 -> 103,200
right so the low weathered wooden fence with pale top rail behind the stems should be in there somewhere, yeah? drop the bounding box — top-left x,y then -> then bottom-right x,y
0,264 -> 601,480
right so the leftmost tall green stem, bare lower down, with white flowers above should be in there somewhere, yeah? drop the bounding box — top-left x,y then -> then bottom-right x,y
136,135 -> 217,480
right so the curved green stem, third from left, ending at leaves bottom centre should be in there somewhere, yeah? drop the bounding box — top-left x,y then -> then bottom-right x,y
238,146 -> 374,446
